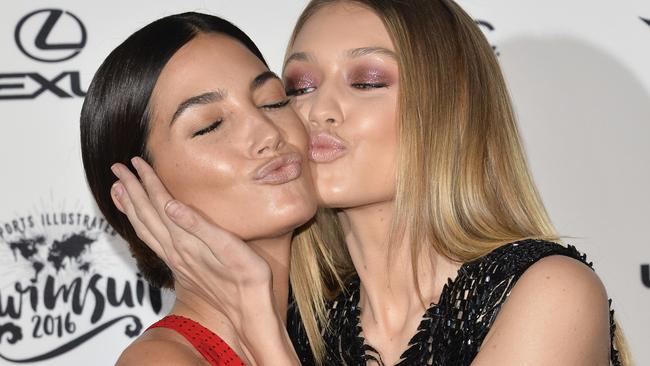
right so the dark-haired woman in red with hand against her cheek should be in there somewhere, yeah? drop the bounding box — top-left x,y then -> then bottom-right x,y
81,13 -> 316,366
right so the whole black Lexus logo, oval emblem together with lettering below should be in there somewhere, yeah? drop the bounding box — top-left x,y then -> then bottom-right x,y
0,9 -> 88,101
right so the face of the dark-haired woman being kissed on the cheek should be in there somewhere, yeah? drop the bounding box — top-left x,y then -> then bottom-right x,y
147,34 -> 316,240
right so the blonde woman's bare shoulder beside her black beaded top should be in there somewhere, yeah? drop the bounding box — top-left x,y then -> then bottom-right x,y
473,255 -> 609,366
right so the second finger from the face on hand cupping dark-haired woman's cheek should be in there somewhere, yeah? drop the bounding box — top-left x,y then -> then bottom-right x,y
111,163 -> 171,250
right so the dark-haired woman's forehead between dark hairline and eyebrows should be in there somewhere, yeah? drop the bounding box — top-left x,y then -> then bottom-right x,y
151,33 -> 267,115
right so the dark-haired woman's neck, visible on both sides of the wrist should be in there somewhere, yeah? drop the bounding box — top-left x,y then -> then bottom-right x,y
170,233 -> 291,355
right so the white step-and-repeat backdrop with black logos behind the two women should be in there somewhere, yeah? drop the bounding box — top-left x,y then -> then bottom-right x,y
0,0 -> 650,366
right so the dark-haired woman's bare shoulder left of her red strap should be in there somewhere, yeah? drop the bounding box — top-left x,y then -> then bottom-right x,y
116,329 -> 207,366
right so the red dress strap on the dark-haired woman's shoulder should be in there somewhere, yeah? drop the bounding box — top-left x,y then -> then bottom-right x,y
148,315 -> 244,366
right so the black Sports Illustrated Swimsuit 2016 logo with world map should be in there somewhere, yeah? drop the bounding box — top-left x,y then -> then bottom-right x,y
0,210 -> 162,365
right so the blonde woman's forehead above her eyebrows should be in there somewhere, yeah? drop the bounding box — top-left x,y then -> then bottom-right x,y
291,2 -> 394,54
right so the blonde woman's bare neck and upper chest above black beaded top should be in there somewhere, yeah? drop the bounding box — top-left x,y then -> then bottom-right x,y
338,200 -> 458,334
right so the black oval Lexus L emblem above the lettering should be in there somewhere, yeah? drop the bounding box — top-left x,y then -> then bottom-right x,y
14,9 -> 86,62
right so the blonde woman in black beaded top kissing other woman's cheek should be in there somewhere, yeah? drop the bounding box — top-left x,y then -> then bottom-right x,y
112,0 -> 629,365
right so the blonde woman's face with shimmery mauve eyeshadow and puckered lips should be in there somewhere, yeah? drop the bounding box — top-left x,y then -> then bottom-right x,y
283,3 -> 399,208
